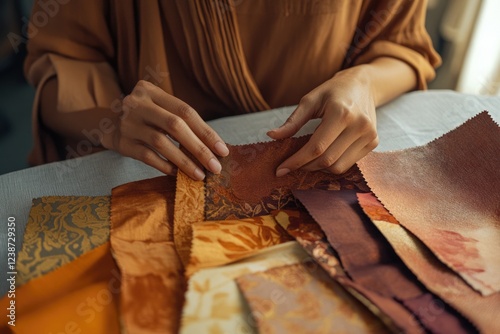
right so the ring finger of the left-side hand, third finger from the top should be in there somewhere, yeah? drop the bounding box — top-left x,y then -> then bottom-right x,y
137,128 -> 205,181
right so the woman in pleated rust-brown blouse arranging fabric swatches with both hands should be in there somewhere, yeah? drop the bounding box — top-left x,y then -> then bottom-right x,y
25,0 -> 440,180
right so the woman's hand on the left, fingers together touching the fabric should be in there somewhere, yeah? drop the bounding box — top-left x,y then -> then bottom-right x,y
102,80 -> 229,180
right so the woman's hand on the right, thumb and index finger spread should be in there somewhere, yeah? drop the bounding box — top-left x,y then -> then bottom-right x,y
268,65 -> 378,177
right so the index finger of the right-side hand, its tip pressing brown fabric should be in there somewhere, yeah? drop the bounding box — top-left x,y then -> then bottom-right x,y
276,117 -> 345,177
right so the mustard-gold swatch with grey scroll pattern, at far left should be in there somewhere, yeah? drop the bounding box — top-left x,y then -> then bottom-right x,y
16,196 -> 109,285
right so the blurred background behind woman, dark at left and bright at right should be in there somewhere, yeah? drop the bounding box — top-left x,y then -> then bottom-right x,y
0,0 -> 500,174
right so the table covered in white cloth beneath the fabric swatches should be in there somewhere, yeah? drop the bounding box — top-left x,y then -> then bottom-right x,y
0,90 -> 500,296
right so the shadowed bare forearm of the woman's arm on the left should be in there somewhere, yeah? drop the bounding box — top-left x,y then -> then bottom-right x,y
40,77 -> 119,145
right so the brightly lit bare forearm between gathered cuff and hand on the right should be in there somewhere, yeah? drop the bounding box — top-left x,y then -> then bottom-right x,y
339,57 -> 417,107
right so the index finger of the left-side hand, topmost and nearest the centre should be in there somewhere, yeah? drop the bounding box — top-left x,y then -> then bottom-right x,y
146,85 -> 229,157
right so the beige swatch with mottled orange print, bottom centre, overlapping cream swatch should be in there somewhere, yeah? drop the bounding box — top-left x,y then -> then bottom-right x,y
236,262 -> 387,334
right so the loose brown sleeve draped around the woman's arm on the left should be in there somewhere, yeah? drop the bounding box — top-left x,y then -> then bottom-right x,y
24,0 -> 121,165
